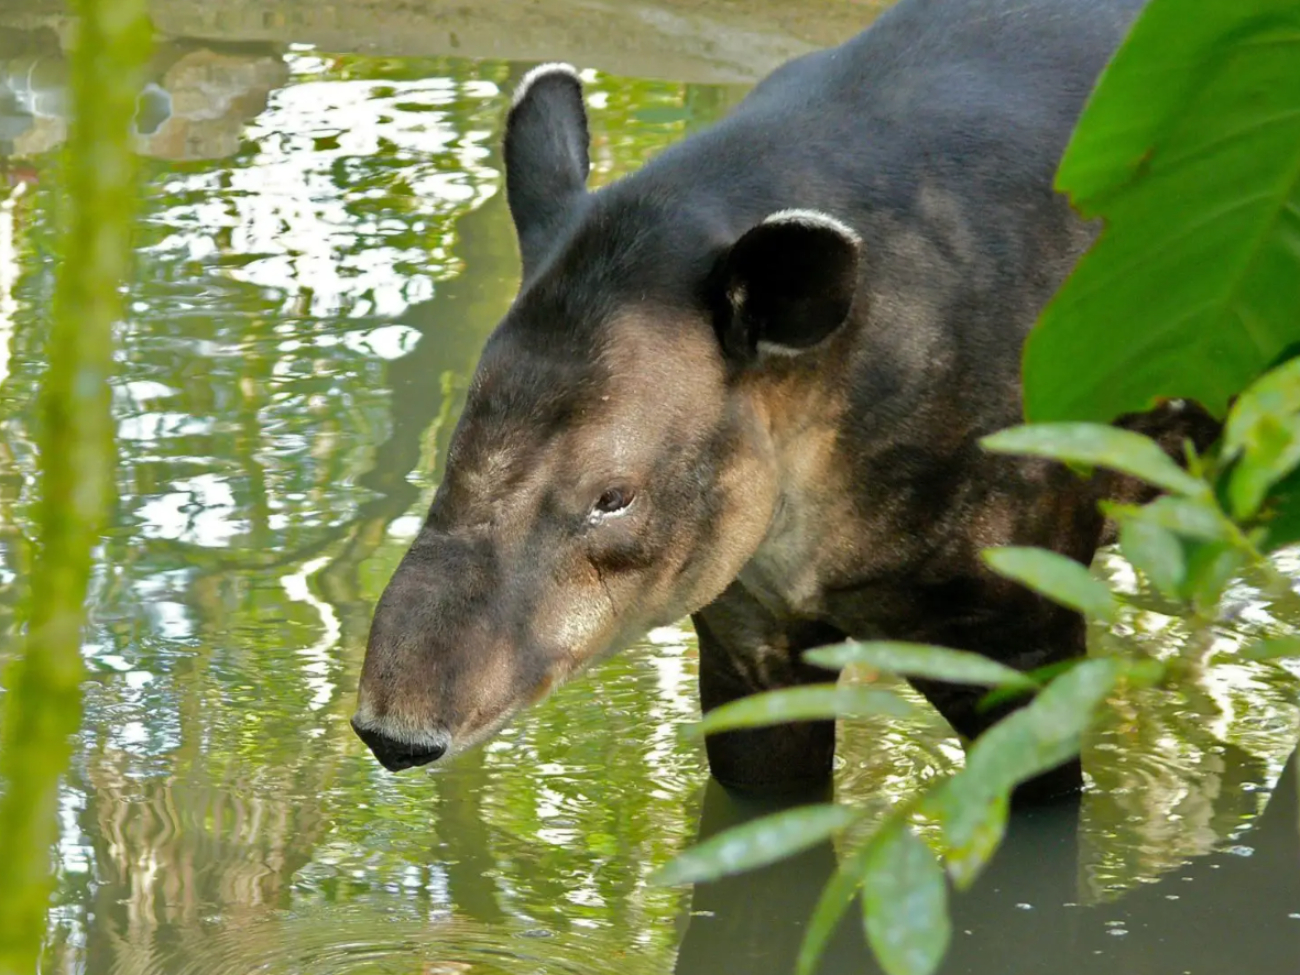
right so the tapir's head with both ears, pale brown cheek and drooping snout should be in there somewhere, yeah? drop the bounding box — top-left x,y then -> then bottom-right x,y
354,65 -> 858,770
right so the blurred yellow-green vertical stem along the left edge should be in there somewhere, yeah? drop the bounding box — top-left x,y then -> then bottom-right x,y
0,0 -> 151,975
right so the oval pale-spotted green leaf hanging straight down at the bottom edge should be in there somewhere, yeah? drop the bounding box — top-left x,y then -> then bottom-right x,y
863,819 -> 952,975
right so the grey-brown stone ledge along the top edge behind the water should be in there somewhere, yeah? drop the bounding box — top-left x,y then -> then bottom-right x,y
0,0 -> 887,82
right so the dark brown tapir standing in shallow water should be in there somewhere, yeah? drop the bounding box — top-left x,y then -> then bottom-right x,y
354,0 -> 1212,793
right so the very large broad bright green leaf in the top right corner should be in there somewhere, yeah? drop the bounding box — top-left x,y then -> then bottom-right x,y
1024,0 -> 1300,420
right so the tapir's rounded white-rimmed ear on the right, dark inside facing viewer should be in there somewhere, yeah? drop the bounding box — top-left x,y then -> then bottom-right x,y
714,209 -> 862,361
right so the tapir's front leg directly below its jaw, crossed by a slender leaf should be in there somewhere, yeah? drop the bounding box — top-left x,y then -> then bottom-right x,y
692,584 -> 844,794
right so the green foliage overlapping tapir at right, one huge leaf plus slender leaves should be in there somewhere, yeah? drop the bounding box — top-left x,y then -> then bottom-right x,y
663,0 -> 1300,975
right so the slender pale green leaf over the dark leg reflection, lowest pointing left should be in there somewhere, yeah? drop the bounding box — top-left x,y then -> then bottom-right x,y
654,803 -> 861,887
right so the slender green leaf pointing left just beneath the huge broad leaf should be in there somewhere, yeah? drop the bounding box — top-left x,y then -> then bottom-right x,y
980,423 -> 1208,494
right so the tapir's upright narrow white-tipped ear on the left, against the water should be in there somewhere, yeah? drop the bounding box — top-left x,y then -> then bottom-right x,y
504,64 -> 592,276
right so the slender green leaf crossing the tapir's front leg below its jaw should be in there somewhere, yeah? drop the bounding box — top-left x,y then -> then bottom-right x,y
690,684 -> 914,735
